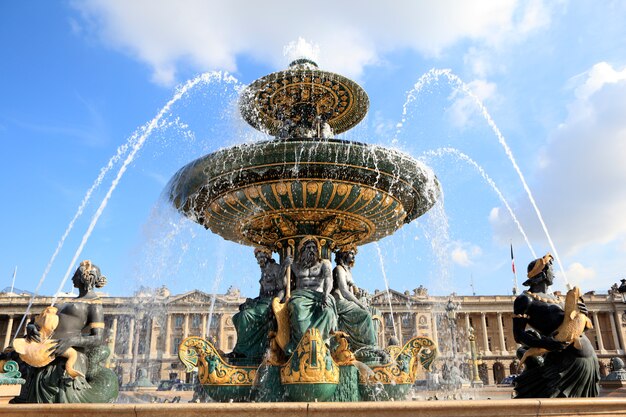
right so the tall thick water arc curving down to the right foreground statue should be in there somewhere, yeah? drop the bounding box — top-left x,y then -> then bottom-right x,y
396,69 -> 570,288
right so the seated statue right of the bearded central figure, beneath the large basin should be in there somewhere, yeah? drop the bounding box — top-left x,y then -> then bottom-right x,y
333,246 -> 376,351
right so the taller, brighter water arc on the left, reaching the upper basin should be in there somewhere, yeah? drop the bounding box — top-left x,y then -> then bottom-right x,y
45,72 -> 236,305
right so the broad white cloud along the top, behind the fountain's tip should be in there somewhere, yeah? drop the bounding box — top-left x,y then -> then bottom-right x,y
73,0 -> 549,83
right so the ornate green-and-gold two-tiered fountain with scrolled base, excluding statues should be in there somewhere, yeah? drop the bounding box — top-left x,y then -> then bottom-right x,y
169,59 -> 439,401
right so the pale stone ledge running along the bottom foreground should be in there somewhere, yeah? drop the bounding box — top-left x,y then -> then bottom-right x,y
0,398 -> 626,417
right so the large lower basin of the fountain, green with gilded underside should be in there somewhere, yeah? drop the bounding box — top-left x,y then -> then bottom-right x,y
170,139 -> 439,252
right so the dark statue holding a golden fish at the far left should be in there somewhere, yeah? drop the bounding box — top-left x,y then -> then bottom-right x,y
16,261 -> 118,403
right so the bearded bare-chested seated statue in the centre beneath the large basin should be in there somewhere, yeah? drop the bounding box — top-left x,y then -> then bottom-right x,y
285,236 -> 337,353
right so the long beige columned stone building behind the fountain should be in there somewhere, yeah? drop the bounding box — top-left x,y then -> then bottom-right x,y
0,287 -> 626,384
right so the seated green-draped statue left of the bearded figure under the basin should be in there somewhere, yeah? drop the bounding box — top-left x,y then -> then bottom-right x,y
228,248 -> 286,361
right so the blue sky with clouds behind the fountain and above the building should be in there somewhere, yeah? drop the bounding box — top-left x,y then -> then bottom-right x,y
0,0 -> 626,295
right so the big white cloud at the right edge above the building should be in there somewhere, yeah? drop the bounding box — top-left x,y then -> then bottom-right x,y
492,62 -> 626,256
